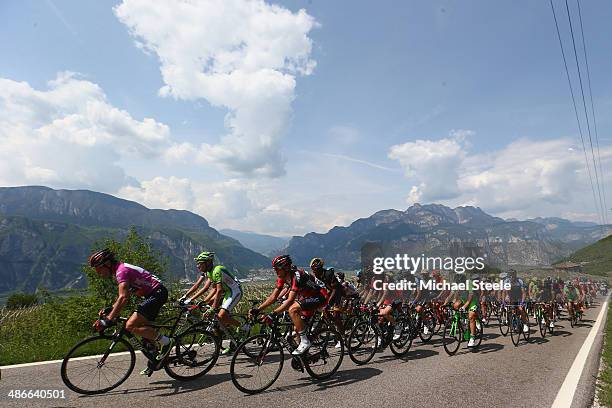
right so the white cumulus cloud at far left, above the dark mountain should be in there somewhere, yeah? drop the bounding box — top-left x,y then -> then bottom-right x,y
0,73 -> 171,192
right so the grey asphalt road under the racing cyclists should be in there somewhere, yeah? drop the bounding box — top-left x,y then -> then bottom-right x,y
0,299 -> 605,407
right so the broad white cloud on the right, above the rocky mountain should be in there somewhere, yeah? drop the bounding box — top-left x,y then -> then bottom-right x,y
389,131 -> 612,221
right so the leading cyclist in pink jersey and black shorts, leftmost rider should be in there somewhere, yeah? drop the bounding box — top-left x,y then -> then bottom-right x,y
89,248 -> 174,376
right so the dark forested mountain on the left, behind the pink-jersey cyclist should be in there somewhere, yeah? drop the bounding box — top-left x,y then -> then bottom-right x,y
0,186 -> 270,293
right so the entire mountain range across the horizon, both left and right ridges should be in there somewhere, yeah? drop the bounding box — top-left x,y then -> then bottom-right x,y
0,186 -> 607,293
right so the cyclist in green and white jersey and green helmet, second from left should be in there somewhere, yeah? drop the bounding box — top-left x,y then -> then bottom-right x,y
179,251 -> 242,354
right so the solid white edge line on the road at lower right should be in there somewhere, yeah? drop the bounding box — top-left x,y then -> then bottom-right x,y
552,296 -> 610,408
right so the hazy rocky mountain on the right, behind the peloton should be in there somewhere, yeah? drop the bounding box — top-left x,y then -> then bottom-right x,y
283,204 -> 607,268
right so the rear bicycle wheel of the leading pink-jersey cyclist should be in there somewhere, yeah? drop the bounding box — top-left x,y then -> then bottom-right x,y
164,325 -> 221,381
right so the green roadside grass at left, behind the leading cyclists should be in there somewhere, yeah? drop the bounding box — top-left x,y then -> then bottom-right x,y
0,283 -> 272,366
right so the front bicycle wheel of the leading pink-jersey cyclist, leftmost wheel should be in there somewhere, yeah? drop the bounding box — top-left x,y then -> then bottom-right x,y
60,335 -> 136,395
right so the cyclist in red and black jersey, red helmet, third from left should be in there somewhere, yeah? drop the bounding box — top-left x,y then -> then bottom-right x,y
249,255 -> 327,356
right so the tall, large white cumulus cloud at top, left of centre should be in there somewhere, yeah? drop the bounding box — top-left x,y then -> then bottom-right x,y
114,0 -> 316,177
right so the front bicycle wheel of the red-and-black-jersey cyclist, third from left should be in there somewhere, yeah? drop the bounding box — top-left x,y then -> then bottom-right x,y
230,334 -> 285,394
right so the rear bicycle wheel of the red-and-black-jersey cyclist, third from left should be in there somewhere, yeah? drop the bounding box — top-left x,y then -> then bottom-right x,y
303,328 -> 344,380
